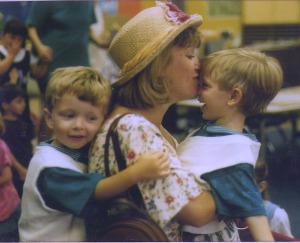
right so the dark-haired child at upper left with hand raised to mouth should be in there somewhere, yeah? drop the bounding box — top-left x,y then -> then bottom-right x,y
0,18 -> 48,126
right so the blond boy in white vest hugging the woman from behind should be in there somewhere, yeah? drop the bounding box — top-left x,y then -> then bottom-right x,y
19,67 -> 169,241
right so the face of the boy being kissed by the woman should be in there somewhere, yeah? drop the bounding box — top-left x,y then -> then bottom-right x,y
198,73 -> 231,123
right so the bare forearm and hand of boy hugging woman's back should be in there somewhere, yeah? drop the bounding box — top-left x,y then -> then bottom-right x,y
94,151 -> 170,200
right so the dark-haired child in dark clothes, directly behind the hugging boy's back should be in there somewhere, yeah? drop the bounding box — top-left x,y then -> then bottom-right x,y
0,83 -> 38,198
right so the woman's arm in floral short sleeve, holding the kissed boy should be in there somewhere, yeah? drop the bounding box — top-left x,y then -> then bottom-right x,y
109,116 -> 216,226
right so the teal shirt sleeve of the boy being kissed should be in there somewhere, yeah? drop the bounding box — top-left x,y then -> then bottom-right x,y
201,164 -> 266,218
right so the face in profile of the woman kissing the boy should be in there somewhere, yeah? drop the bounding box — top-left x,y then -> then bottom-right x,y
163,46 -> 199,103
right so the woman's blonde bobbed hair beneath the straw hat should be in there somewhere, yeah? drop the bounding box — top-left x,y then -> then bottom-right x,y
114,27 -> 200,109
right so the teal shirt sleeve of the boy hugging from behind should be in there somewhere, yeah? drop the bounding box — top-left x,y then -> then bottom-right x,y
38,167 -> 103,217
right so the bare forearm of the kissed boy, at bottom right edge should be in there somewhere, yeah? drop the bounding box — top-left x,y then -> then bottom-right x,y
246,215 -> 274,241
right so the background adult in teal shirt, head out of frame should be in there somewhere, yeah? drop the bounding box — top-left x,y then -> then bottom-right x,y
26,1 -> 107,141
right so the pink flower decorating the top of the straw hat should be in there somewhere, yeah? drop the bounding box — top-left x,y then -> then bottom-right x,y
156,0 -> 190,24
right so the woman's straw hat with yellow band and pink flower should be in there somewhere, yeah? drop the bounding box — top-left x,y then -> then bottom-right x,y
109,0 -> 202,86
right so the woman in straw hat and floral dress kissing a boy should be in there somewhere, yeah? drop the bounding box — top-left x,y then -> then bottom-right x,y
89,2 -> 238,241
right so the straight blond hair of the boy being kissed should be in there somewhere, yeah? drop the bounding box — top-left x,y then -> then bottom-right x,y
201,48 -> 283,116
